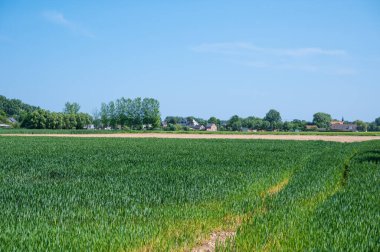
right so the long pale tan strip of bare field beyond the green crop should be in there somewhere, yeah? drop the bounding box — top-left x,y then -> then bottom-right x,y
0,133 -> 380,143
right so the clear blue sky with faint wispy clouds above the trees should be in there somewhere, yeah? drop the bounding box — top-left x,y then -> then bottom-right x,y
0,0 -> 380,121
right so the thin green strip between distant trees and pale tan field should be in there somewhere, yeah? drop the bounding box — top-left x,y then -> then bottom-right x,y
0,129 -> 380,136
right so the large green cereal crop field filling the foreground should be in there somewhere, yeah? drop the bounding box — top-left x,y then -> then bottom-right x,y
0,136 -> 380,251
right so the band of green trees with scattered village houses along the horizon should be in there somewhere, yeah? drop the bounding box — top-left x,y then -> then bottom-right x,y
0,95 -> 380,132
